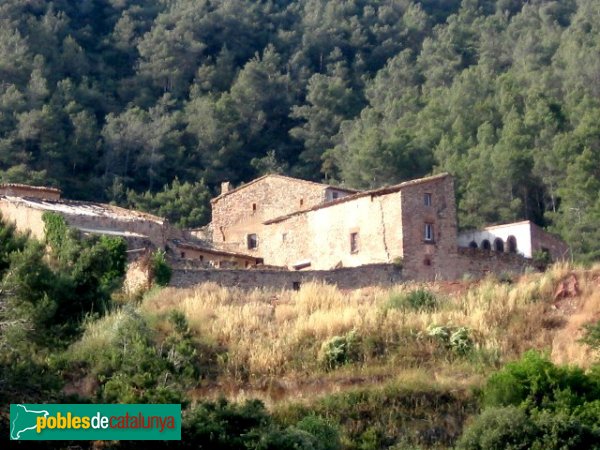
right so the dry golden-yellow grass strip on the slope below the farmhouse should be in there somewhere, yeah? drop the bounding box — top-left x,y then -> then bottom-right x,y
142,264 -> 600,388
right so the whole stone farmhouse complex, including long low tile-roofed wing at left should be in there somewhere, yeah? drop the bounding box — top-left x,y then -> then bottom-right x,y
0,173 -> 569,288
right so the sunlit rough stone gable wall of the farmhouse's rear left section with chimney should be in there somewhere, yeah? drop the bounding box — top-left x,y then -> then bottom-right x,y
211,176 -> 325,253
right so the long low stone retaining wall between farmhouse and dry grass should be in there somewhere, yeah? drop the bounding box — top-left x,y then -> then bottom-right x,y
171,264 -> 403,289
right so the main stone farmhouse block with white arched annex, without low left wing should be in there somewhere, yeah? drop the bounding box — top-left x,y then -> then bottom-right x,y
211,173 -> 568,280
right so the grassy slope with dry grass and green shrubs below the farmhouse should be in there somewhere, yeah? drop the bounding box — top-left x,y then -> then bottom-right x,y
58,265 -> 600,449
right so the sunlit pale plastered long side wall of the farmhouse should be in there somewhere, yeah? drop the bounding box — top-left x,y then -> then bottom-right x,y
259,192 -> 402,270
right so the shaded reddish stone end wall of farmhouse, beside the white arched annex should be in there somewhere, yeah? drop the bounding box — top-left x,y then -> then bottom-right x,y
402,176 -> 457,280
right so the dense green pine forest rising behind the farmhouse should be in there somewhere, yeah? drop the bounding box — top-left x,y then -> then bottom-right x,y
0,0 -> 600,260
